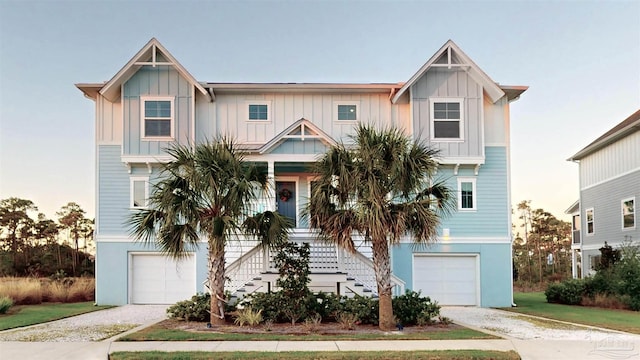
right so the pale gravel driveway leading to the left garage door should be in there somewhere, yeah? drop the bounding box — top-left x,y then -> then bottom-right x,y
0,305 -> 167,342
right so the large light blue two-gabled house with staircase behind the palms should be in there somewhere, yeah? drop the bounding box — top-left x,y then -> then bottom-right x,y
76,39 -> 527,306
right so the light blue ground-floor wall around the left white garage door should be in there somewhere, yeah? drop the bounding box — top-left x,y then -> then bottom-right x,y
96,242 -> 207,305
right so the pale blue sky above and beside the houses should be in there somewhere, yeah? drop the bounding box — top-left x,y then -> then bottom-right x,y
0,0 -> 640,225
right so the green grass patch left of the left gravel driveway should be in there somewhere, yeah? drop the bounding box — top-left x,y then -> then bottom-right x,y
0,301 -> 112,331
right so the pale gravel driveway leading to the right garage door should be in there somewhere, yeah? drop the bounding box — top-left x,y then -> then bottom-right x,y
440,306 -> 640,341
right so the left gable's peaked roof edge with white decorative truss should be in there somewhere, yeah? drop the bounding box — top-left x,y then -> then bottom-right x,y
76,38 -> 211,101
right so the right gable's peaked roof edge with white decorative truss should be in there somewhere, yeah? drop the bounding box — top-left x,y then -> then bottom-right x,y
392,40 -> 526,104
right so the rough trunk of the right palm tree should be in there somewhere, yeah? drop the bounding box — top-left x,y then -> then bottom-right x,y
372,238 -> 396,331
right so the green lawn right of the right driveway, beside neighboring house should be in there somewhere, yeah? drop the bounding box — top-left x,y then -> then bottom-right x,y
503,292 -> 640,334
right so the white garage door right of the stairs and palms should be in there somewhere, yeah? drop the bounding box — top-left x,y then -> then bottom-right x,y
413,255 -> 479,305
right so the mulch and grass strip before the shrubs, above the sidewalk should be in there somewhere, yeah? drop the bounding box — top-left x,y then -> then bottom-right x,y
118,321 -> 497,341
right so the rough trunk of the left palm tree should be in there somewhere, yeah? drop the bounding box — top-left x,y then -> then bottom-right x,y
209,238 -> 225,325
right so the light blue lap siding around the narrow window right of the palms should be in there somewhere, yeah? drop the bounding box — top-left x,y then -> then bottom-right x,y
437,147 -> 511,237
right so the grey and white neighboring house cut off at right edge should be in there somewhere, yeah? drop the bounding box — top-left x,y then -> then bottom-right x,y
566,110 -> 640,277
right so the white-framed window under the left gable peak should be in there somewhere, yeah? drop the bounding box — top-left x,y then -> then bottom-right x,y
140,96 -> 174,140
